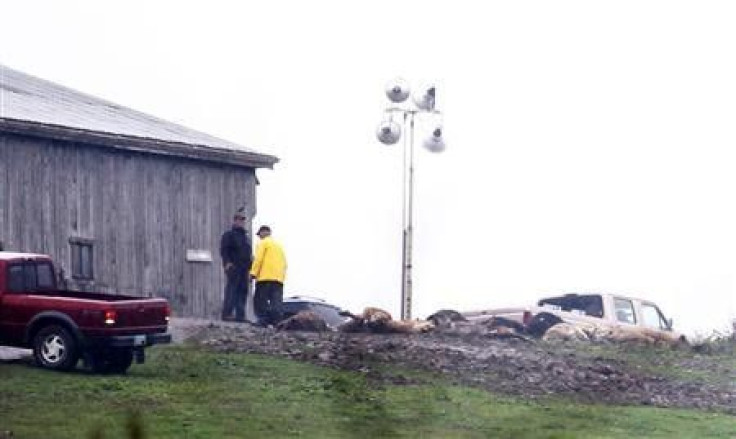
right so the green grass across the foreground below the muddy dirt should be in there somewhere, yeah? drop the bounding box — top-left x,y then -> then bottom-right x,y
0,347 -> 736,439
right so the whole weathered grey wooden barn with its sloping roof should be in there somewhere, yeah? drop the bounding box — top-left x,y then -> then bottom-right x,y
0,65 -> 278,317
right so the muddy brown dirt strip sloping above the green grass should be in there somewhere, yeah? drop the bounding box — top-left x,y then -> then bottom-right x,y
171,319 -> 736,414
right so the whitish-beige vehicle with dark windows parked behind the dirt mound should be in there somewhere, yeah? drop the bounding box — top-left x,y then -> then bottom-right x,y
462,294 -> 681,338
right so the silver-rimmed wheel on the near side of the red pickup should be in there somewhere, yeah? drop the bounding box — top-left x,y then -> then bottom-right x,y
33,325 -> 79,370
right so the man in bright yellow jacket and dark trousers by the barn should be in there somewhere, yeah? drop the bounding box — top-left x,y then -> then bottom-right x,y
250,226 -> 286,326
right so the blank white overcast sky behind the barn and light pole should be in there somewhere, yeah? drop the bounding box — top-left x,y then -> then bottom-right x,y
0,0 -> 736,332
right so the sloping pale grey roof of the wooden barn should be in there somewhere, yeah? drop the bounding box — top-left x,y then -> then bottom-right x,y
0,64 -> 278,168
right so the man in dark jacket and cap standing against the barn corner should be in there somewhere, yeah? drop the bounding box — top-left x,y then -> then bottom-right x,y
220,207 -> 253,322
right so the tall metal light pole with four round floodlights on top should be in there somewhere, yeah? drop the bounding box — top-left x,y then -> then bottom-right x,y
376,79 -> 445,320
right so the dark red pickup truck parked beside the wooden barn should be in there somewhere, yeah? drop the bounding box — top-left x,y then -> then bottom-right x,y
0,251 -> 171,373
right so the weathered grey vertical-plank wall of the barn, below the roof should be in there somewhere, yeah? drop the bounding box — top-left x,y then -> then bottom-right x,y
0,133 -> 256,317
